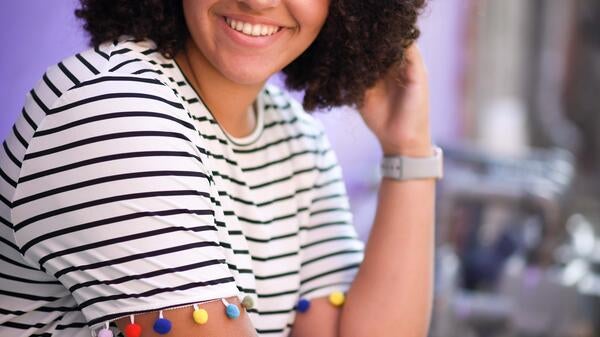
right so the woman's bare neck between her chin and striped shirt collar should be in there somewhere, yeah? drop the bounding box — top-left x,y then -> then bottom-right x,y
175,41 -> 264,137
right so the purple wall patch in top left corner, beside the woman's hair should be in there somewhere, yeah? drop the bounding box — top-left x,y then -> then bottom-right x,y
0,0 -> 86,139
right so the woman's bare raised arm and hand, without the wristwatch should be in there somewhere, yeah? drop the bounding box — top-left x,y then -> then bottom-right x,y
293,46 -> 435,337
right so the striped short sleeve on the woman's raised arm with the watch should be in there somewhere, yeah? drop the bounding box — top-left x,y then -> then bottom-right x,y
300,124 -> 364,299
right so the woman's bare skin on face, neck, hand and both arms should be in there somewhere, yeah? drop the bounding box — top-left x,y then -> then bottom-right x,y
81,0 -> 435,337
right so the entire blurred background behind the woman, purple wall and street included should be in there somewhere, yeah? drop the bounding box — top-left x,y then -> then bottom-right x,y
0,0 -> 600,337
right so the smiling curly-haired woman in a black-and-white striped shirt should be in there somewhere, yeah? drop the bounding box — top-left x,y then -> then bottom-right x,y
0,0 -> 440,337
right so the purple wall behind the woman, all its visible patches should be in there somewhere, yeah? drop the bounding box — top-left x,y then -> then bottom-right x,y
0,0 -> 468,237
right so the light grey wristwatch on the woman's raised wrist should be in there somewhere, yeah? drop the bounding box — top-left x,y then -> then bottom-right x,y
381,146 -> 444,180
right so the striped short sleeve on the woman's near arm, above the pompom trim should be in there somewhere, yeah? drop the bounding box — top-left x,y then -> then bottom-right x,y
11,75 -> 238,328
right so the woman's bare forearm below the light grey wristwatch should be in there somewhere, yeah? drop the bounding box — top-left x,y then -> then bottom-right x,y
340,179 -> 435,337
